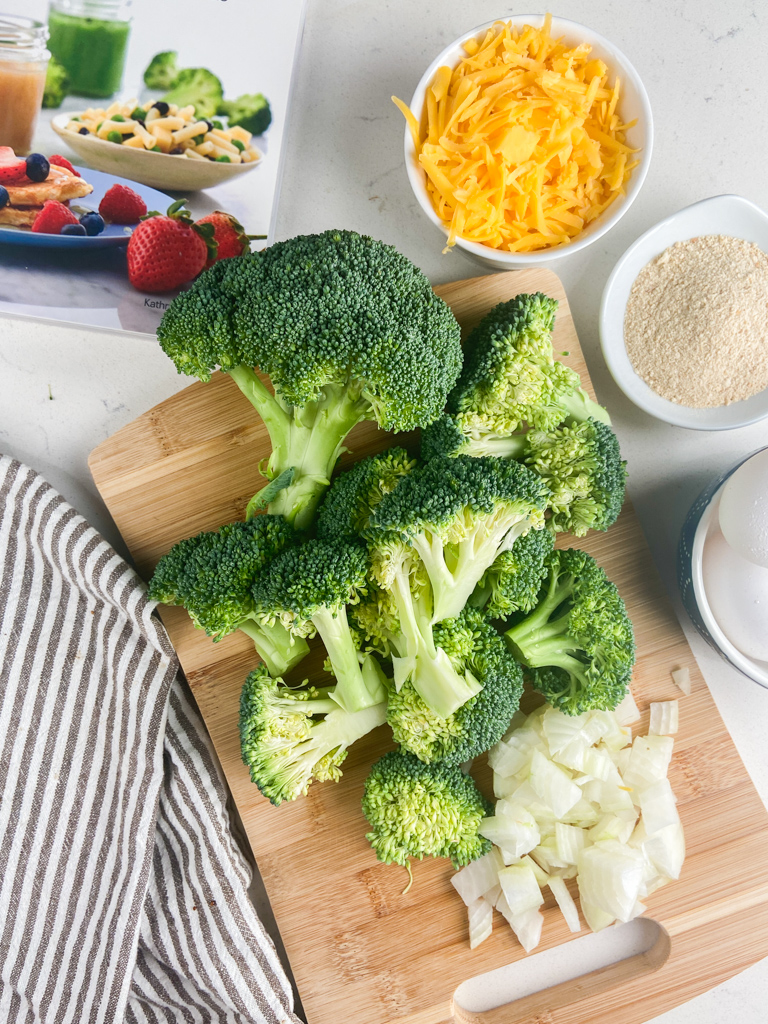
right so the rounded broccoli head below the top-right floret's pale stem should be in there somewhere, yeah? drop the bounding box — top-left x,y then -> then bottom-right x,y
525,419 -> 627,537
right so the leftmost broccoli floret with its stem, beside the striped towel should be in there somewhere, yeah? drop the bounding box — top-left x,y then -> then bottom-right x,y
150,515 -> 309,675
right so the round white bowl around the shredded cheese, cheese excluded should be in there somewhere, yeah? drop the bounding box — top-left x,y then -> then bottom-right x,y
404,14 -> 653,270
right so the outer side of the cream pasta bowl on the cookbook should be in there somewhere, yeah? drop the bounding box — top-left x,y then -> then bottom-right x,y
51,111 -> 261,191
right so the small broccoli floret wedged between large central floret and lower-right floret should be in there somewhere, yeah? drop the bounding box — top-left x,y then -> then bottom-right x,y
470,529 -> 555,618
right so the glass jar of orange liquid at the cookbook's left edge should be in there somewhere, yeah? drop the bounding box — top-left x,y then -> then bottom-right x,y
0,14 -> 50,157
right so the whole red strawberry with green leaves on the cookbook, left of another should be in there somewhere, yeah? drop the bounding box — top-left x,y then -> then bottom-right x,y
128,199 -> 216,292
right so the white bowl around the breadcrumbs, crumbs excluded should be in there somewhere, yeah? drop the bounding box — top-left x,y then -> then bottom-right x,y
600,196 -> 768,430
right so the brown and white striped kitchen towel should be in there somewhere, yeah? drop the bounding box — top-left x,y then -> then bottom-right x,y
0,457 -> 299,1024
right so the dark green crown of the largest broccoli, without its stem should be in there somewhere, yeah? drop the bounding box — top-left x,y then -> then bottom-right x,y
158,230 -> 462,430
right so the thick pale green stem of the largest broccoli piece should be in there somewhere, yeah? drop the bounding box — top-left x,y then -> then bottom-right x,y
227,366 -> 373,529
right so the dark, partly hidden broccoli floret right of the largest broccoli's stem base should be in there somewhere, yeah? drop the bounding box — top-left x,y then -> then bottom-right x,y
316,447 -> 417,541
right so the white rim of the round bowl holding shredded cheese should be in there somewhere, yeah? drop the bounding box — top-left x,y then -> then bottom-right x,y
403,14 -> 653,267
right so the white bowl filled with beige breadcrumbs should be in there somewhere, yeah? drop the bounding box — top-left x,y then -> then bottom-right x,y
600,196 -> 768,430
